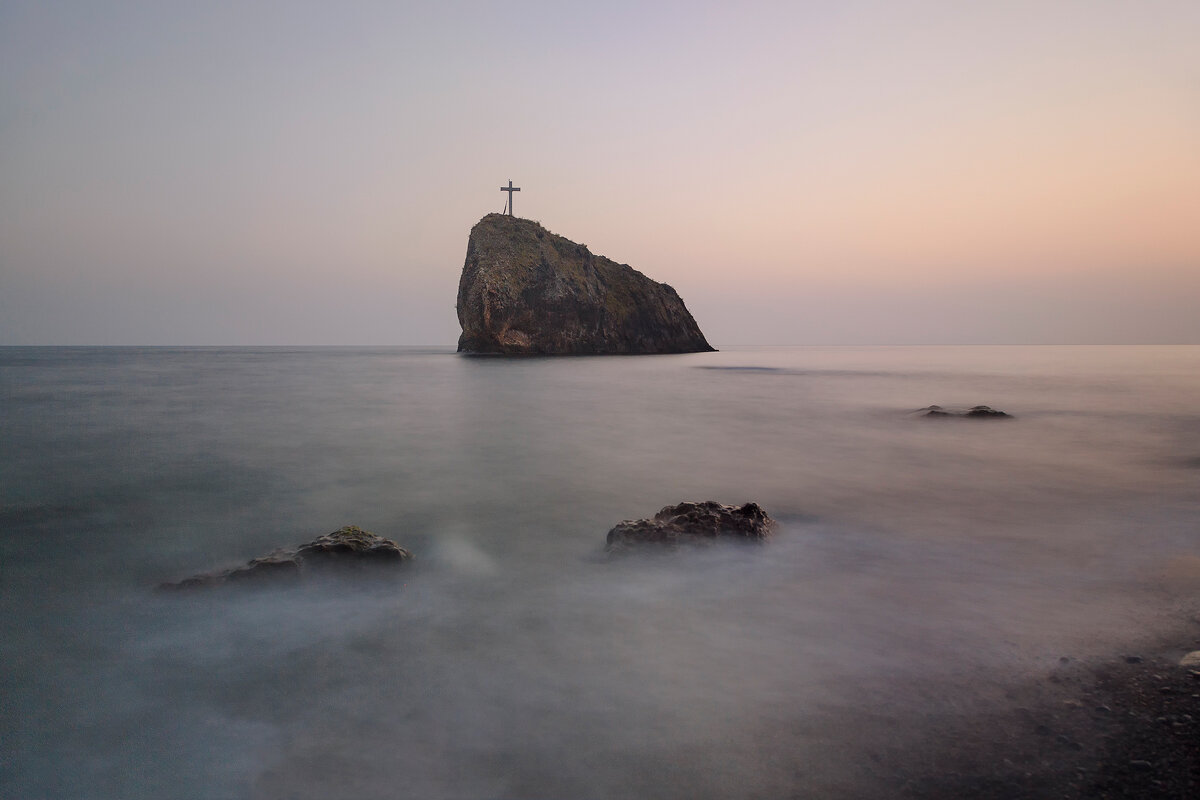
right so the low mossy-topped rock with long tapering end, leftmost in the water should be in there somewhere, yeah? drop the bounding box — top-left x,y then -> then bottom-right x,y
158,525 -> 413,589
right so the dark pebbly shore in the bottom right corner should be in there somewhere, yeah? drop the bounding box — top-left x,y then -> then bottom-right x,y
892,621 -> 1200,800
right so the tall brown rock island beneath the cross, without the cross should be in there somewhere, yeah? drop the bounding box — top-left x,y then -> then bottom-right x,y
458,213 -> 713,355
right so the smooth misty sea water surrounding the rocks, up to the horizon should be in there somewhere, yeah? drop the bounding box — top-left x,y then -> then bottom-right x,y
0,347 -> 1200,799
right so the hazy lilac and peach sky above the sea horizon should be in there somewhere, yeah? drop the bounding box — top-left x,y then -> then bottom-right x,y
0,0 -> 1200,347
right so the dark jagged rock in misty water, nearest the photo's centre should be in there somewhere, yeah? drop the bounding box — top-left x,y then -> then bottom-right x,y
605,500 -> 775,553
